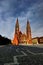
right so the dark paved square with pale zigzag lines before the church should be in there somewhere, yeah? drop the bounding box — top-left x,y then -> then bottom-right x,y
0,45 -> 43,65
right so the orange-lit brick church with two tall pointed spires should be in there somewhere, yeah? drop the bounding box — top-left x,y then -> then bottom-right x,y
12,19 -> 32,45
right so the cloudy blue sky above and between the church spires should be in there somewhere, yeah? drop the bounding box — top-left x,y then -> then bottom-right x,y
0,0 -> 43,39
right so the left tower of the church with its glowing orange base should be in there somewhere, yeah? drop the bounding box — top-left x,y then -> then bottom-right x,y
12,18 -> 19,45
